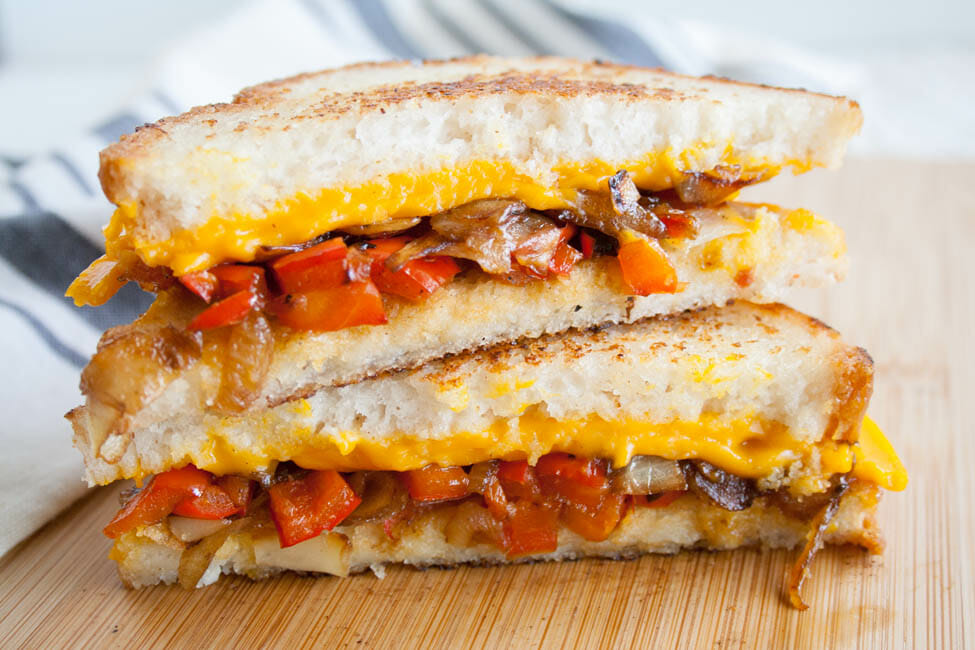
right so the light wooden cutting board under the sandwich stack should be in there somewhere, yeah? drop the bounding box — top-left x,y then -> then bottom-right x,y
0,161 -> 975,648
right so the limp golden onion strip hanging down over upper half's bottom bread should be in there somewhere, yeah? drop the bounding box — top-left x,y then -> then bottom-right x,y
216,312 -> 274,412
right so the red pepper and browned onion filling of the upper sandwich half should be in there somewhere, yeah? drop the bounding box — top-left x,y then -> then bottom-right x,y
74,168 -> 757,312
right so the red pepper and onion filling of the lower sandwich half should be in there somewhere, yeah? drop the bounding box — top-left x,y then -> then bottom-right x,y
104,419 -> 906,606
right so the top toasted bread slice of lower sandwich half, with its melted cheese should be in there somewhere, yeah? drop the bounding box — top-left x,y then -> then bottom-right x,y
75,302 -> 887,492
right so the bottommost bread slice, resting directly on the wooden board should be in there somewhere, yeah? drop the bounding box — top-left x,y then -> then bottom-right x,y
111,482 -> 883,588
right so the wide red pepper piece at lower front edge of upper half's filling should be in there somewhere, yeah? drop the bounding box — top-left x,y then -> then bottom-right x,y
269,281 -> 386,332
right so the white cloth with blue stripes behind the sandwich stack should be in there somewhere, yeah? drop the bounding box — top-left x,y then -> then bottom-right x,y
0,0 -> 868,554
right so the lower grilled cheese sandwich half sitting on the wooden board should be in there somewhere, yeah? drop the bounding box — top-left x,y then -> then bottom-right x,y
95,302 -> 906,608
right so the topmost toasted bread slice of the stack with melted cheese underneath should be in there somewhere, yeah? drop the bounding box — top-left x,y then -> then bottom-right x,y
100,56 -> 861,275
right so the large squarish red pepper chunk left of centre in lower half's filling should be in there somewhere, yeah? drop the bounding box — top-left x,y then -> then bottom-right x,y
268,470 -> 362,548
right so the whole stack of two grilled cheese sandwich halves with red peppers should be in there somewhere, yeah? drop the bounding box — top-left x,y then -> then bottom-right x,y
68,57 -> 906,604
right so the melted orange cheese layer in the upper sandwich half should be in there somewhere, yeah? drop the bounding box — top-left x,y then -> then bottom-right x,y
105,154 -> 780,275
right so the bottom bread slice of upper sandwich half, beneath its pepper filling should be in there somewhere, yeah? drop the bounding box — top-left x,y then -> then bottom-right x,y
71,205 -> 846,470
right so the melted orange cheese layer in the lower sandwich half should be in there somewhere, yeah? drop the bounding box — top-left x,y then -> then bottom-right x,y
184,412 -> 907,492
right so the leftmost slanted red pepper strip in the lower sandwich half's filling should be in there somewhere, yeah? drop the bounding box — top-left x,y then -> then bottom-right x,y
103,465 -> 212,538
